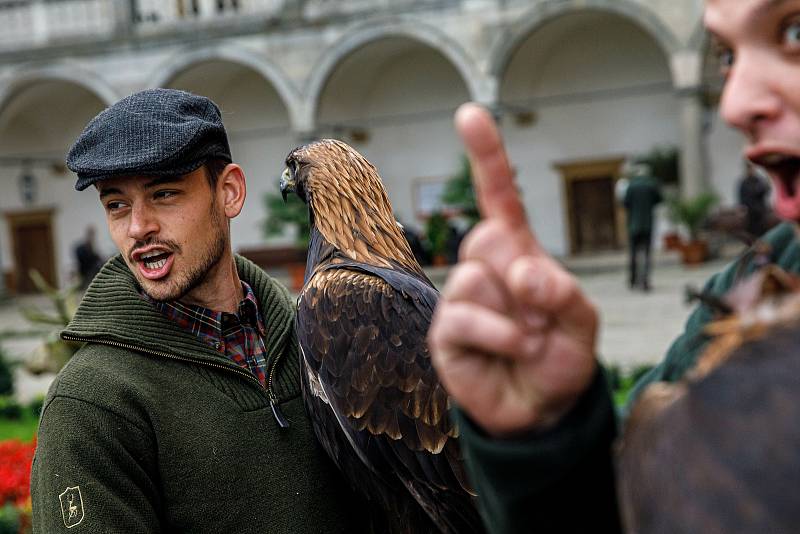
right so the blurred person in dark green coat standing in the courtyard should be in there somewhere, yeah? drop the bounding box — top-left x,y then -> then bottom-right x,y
623,164 -> 663,291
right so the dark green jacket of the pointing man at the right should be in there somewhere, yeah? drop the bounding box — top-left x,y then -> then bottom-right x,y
459,223 -> 800,534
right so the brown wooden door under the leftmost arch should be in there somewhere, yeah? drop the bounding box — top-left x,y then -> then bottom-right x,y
6,209 -> 57,294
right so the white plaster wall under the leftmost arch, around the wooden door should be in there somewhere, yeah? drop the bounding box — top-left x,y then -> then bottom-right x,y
0,82 -> 115,284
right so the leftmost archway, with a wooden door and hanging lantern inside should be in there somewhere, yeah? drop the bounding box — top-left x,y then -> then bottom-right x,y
0,76 -> 110,291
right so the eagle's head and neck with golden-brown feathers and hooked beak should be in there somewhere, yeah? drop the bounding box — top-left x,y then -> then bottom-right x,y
280,139 -> 421,272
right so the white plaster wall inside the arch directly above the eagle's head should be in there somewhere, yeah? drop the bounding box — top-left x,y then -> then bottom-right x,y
319,39 -> 469,233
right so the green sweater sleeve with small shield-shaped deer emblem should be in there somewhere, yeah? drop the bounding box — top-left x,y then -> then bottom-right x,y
31,396 -> 160,534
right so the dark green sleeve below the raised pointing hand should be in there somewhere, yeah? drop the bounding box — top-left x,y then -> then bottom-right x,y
458,371 -> 621,534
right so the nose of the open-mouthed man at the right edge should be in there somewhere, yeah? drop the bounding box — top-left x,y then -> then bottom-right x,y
720,54 -> 781,136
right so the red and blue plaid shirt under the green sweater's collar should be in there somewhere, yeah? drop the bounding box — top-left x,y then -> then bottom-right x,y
144,282 -> 267,387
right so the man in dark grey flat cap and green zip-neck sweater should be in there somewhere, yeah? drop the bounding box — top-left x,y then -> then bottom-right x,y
31,89 -> 360,533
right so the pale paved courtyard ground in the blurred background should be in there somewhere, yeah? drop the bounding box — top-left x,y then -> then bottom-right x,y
0,254 -> 728,400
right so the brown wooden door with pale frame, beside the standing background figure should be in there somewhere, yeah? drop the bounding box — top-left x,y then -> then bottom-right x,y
556,158 -> 625,254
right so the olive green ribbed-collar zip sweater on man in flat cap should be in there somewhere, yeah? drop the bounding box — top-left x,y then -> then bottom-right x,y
31,257 -> 362,534
